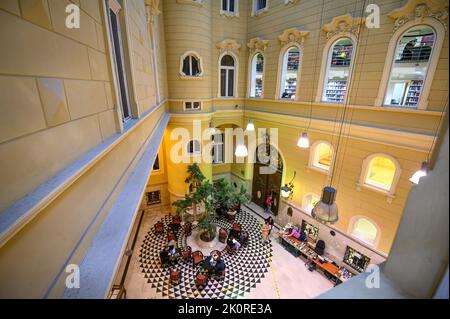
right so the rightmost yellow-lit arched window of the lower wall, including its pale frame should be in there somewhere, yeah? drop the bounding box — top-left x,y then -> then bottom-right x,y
361,154 -> 400,194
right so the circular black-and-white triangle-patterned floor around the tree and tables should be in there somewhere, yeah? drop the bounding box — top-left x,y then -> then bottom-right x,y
139,211 -> 272,299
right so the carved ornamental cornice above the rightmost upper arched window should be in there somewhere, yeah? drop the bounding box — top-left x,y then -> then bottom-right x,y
388,0 -> 448,32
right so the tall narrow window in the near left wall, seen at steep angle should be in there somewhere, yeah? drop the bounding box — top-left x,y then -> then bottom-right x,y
107,0 -> 131,122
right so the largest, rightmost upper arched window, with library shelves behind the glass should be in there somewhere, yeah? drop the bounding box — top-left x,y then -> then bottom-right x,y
384,25 -> 436,108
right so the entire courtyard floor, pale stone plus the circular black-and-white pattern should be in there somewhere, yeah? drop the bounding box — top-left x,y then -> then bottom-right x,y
125,208 -> 333,299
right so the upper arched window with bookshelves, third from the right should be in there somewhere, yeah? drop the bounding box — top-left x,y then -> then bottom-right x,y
280,47 -> 300,100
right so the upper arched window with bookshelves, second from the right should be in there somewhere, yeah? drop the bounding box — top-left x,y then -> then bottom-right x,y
322,37 -> 354,103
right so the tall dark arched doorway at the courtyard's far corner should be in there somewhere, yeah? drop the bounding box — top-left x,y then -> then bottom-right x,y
252,143 -> 283,216
